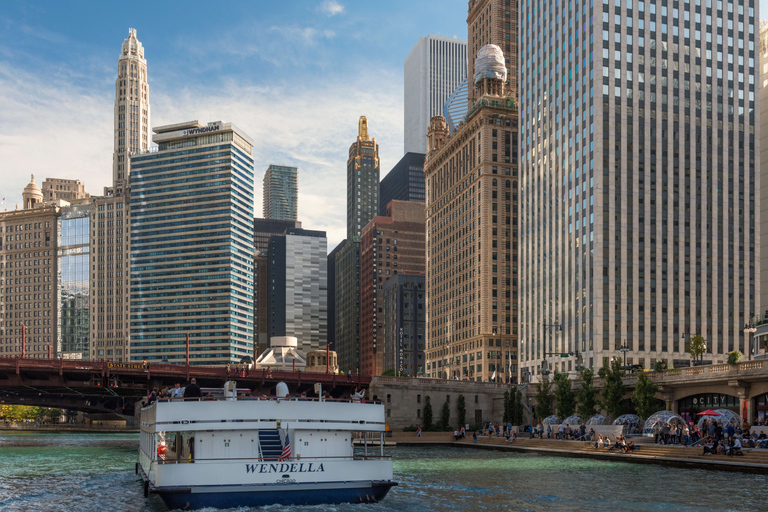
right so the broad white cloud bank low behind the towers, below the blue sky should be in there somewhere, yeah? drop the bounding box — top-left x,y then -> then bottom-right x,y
0,64 -> 402,249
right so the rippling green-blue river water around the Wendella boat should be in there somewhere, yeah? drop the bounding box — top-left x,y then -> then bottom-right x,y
0,432 -> 768,512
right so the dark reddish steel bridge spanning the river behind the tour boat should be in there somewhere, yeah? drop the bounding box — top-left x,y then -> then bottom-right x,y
0,357 -> 371,416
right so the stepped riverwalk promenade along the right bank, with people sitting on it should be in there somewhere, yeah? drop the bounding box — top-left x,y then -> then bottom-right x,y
387,432 -> 768,474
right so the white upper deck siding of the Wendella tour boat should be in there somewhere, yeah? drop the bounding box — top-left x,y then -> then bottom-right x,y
141,397 -> 385,433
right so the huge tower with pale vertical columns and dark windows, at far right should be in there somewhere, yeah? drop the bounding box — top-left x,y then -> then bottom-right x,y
520,0 -> 759,379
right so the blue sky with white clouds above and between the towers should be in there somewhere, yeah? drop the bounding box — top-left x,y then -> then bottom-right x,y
0,0 -> 468,251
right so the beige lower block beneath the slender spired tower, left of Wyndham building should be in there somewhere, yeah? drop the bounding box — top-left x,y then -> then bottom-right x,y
89,195 -> 131,361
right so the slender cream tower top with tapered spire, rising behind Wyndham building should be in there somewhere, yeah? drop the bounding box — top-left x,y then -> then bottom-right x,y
112,28 -> 149,195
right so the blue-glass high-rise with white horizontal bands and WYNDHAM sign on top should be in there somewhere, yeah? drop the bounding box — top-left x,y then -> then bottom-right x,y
130,121 -> 254,364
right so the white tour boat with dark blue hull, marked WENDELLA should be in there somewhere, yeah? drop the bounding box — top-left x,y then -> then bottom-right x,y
136,382 -> 397,510
